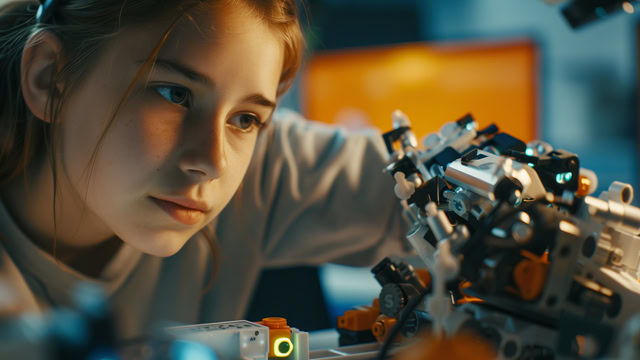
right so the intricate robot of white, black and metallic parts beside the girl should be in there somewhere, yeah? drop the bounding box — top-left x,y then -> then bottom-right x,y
350,111 -> 640,359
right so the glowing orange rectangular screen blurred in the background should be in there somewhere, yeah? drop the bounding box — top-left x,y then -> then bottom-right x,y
301,41 -> 537,141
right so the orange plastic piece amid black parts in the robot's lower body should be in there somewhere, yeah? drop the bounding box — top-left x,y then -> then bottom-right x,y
505,250 -> 549,300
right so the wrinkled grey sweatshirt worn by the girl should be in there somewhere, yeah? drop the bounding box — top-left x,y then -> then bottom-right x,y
0,111 -> 407,338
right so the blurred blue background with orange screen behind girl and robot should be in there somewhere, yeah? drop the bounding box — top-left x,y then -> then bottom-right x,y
247,0 -> 640,330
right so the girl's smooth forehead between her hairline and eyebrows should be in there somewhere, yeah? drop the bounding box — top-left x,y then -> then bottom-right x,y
97,5 -> 284,99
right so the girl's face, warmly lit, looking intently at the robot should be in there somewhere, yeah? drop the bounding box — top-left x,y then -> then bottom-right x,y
60,5 -> 284,256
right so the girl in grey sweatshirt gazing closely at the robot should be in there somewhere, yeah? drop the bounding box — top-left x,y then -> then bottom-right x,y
0,0 -> 406,337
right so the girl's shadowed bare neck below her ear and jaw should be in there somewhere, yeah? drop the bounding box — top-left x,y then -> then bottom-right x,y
0,157 -> 122,277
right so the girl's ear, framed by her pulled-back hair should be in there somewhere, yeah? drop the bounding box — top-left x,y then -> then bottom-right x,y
20,31 -> 62,123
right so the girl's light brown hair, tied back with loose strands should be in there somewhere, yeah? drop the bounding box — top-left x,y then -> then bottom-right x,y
0,0 -> 303,287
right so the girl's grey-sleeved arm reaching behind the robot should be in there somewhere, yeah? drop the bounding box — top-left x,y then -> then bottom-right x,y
212,111 -> 408,266
